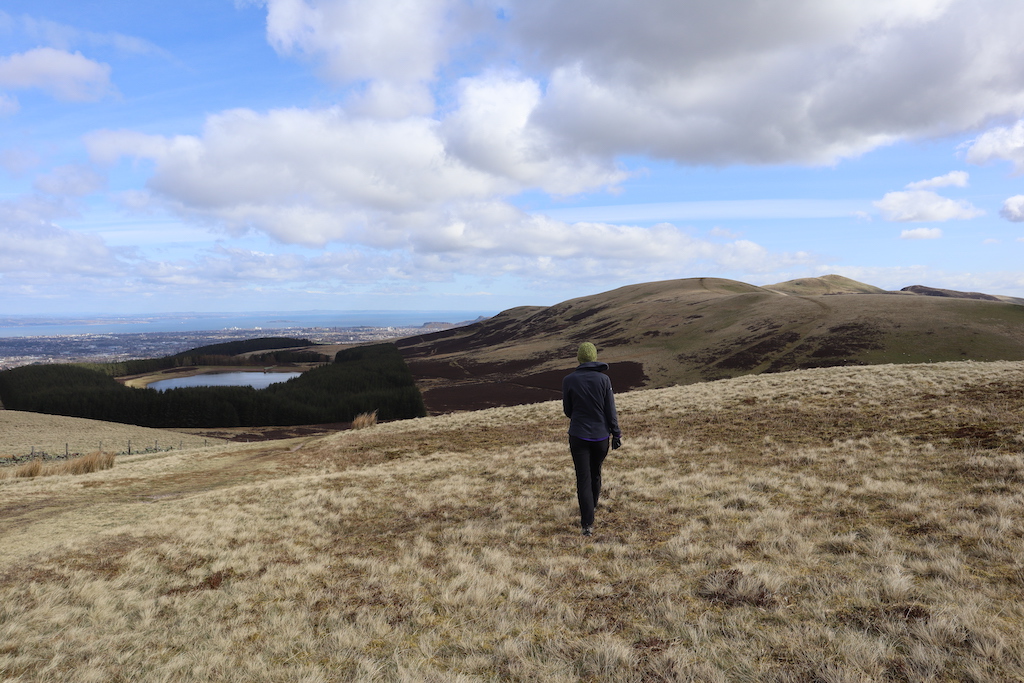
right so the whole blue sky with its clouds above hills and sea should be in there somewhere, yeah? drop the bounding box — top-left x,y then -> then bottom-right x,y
0,0 -> 1024,314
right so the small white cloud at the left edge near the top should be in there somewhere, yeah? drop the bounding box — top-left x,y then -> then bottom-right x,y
0,47 -> 113,101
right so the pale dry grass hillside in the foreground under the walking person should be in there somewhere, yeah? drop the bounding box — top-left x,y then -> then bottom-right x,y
0,361 -> 1024,682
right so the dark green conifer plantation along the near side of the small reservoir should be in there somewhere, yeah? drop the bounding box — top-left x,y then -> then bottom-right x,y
0,343 -> 426,428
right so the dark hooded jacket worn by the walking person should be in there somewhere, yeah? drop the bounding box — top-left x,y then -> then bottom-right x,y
562,360 -> 623,441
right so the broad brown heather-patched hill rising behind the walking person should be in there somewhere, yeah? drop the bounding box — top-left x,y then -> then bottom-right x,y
396,275 -> 1024,413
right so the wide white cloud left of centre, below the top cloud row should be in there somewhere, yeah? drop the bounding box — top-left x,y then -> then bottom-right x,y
86,102 -> 622,248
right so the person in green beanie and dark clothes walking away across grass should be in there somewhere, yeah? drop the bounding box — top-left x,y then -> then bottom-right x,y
562,342 -> 623,536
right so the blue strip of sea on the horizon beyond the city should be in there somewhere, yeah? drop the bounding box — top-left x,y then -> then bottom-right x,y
0,310 -> 495,338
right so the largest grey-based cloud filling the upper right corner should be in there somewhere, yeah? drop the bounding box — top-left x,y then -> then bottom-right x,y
506,0 -> 1024,164
